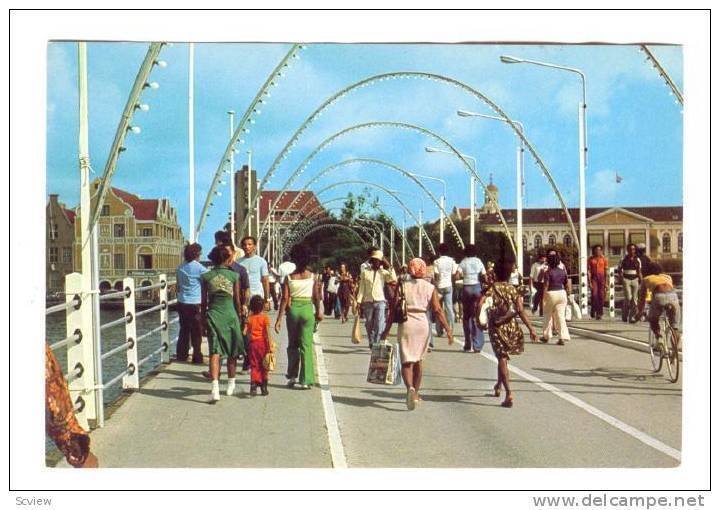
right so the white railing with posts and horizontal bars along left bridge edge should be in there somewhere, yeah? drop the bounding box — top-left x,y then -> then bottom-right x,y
45,273 -> 178,429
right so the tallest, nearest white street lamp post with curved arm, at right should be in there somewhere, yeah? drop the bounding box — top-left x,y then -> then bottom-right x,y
500,55 -> 588,315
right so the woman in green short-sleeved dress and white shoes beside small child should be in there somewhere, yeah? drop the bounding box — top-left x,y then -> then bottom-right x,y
200,246 -> 245,402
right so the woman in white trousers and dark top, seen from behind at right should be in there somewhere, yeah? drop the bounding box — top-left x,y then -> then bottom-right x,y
540,250 -> 571,345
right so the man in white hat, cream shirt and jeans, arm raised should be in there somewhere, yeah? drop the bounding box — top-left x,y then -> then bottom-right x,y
357,250 -> 397,348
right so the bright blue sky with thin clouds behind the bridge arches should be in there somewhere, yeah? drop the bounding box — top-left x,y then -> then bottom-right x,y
47,43 -> 683,246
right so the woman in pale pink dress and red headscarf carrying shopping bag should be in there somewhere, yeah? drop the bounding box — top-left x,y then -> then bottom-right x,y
381,258 -> 453,411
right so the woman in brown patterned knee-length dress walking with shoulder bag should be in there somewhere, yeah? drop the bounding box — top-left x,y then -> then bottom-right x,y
476,261 -> 538,407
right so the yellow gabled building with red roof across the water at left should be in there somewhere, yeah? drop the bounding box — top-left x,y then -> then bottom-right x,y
74,180 -> 185,290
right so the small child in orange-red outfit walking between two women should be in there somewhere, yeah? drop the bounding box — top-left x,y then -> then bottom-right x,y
245,296 -> 272,395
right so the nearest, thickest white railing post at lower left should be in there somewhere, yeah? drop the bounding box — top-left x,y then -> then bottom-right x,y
65,273 -> 97,430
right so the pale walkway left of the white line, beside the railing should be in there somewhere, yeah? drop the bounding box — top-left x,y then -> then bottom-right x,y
91,314 -> 331,468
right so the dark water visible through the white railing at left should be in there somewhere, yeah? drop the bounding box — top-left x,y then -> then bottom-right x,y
45,309 -> 180,462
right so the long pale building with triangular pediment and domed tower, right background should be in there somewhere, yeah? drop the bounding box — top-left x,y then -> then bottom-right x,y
451,183 -> 683,263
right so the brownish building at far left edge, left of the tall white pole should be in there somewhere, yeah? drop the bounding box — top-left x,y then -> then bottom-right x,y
45,195 -> 75,294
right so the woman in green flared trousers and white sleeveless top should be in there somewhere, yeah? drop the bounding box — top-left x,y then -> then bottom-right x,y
275,245 -> 322,390
